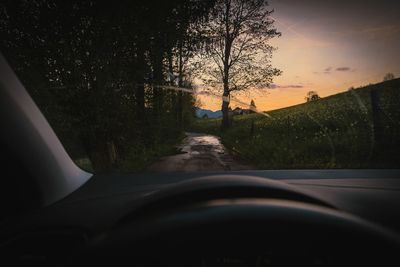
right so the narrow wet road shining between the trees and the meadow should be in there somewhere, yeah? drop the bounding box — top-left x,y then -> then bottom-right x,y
148,133 -> 252,172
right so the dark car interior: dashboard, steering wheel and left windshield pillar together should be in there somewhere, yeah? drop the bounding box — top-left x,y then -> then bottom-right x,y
0,1 -> 400,267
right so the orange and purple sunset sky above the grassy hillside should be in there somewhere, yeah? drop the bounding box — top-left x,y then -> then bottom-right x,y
200,0 -> 400,111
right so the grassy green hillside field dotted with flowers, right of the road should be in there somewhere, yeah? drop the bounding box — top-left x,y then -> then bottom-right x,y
191,79 -> 400,169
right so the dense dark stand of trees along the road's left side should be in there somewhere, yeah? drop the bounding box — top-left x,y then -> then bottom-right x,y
0,0 -> 213,172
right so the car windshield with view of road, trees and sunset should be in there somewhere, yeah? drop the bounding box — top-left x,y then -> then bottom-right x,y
0,0 -> 400,173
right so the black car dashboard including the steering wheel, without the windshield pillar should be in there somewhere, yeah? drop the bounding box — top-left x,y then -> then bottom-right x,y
1,170 -> 400,266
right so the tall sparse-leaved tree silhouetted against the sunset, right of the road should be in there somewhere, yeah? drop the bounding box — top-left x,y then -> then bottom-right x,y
202,0 -> 281,129
